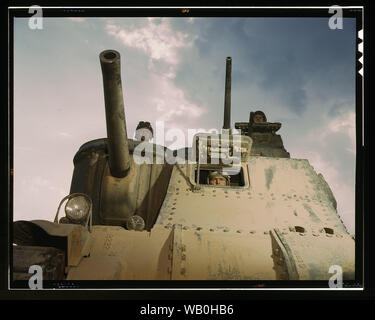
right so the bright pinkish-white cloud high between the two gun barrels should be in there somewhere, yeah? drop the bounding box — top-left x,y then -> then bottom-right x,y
106,18 -> 206,129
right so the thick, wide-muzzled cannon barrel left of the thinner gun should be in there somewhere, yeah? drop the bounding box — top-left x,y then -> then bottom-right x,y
99,50 -> 130,178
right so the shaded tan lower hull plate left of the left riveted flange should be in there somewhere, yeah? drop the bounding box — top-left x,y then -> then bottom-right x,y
67,226 -> 172,280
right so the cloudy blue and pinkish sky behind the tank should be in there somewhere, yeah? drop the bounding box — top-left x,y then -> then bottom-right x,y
13,18 -> 356,234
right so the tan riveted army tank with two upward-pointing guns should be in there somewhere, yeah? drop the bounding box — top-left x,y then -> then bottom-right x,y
12,50 -> 355,281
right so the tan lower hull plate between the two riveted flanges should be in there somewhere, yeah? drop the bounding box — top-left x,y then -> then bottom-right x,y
172,225 -> 276,280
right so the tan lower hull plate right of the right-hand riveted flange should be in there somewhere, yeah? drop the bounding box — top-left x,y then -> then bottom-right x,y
271,229 -> 355,280
